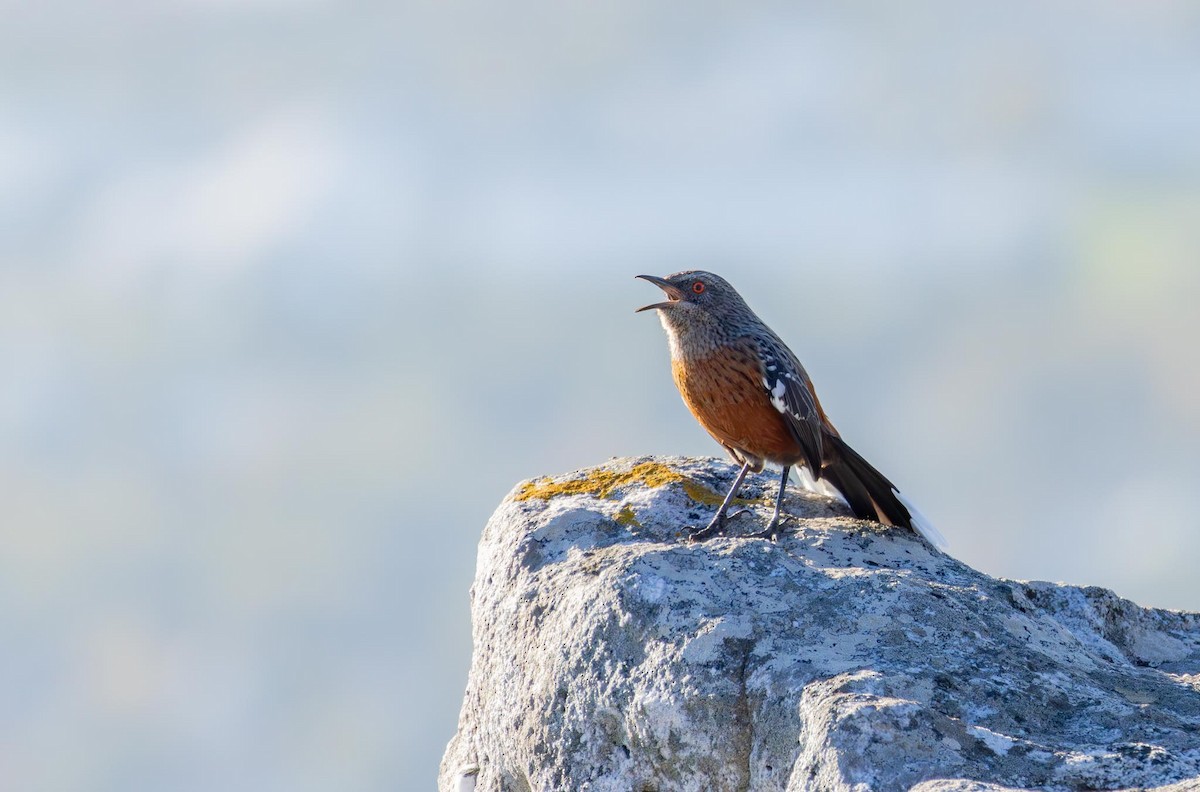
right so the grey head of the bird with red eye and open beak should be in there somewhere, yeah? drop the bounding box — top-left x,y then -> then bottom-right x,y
637,270 -> 762,350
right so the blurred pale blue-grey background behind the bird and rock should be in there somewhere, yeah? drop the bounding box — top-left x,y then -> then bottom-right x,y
0,0 -> 1200,792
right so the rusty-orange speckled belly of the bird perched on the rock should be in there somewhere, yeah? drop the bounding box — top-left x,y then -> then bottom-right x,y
671,352 -> 803,464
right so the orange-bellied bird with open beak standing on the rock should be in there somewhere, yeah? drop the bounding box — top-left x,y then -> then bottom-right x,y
636,270 -> 946,547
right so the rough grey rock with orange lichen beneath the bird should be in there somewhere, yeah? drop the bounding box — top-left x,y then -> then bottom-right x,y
439,457 -> 1200,792
